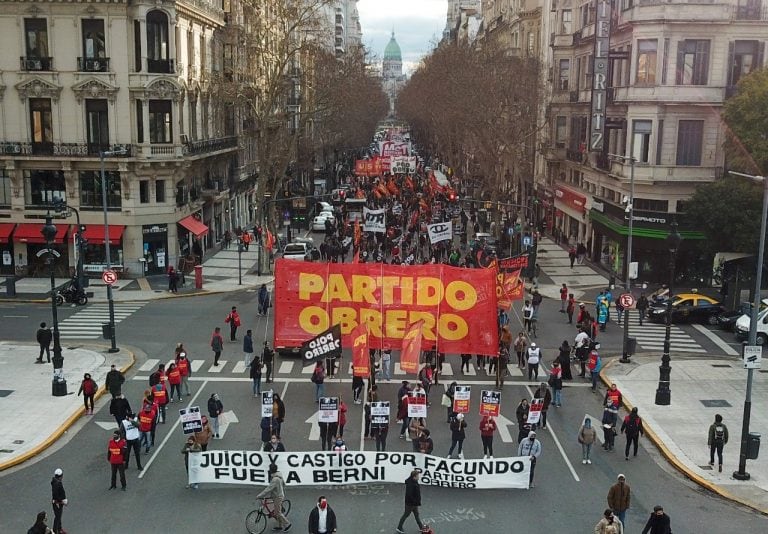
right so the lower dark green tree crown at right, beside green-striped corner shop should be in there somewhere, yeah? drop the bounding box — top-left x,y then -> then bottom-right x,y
685,177 -> 763,253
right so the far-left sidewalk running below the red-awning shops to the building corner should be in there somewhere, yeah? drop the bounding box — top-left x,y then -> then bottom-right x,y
0,248 -> 274,302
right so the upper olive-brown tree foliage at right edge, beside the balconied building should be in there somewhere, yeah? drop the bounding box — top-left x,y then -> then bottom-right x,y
723,69 -> 768,176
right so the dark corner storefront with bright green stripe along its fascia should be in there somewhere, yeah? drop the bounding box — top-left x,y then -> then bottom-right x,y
589,199 -> 712,284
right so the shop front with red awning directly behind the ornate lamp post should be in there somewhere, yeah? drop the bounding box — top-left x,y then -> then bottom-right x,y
13,223 -> 74,278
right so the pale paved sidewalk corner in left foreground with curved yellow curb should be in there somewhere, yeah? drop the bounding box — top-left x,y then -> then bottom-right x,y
0,342 -> 134,471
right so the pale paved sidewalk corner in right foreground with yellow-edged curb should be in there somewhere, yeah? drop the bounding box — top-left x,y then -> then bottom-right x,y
601,354 -> 768,513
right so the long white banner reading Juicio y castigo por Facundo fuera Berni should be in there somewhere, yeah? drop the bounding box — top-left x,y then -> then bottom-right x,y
189,450 -> 531,489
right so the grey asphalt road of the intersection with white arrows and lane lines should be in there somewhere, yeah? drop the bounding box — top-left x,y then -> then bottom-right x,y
0,292 -> 768,534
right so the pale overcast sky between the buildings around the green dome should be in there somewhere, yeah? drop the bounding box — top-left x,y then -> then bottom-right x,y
357,0 -> 448,73
